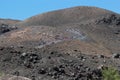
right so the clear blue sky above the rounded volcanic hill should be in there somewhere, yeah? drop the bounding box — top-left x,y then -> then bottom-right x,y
0,0 -> 120,20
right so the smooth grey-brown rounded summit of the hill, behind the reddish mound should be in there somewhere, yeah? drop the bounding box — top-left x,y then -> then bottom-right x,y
19,6 -> 113,26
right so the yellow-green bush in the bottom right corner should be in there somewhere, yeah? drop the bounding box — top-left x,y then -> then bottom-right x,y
102,67 -> 120,80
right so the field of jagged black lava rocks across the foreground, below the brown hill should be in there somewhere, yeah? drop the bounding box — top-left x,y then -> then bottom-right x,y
0,47 -> 119,80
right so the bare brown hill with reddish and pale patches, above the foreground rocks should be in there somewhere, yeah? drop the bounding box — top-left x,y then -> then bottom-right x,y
0,6 -> 120,53
